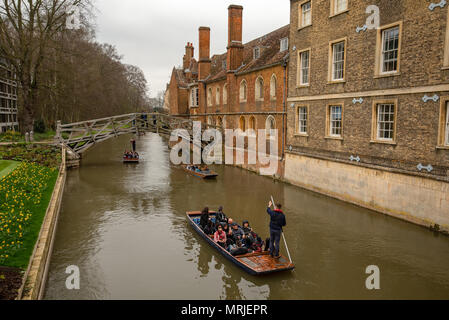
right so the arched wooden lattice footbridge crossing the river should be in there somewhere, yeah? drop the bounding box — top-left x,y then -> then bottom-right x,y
55,113 -> 221,159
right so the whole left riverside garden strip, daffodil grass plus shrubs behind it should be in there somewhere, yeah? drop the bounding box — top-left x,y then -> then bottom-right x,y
0,144 -> 61,270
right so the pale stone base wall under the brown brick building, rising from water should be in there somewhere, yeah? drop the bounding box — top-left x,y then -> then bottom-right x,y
282,153 -> 449,234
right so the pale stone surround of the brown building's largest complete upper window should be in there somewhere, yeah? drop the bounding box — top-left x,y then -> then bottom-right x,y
374,20 -> 403,78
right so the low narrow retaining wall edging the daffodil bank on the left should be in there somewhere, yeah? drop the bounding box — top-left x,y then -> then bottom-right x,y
17,147 -> 67,300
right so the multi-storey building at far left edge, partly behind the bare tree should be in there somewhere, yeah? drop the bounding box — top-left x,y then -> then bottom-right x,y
0,58 -> 19,133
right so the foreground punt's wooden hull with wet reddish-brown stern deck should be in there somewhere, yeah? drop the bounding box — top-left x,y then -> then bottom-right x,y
186,211 -> 295,275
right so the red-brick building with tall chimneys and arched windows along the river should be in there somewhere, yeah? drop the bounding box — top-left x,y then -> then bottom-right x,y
168,5 -> 289,170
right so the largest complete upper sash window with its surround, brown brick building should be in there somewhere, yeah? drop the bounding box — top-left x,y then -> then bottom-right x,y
376,22 -> 402,75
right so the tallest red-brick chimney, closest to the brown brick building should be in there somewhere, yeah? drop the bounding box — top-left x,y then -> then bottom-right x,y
227,5 -> 243,71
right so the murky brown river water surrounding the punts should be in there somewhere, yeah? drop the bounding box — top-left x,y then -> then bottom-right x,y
45,134 -> 449,299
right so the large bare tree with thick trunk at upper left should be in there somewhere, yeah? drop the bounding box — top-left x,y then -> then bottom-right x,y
0,0 -> 88,131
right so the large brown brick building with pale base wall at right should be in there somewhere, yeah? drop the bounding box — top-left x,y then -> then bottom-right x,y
285,0 -> 449,230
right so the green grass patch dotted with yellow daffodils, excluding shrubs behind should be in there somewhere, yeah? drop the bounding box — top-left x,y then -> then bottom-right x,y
0,162 -> 58,268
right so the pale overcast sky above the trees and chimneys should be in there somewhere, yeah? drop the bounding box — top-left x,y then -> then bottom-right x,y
96,0 -> 290,97
